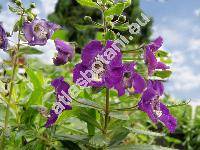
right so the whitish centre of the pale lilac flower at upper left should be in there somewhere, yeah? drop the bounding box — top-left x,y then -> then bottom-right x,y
34,23 -> 48,39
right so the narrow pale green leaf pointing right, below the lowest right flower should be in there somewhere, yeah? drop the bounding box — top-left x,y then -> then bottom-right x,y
126,127 -> 165,137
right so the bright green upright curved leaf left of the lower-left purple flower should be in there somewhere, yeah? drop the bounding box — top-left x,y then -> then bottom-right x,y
26,68 -> 44,105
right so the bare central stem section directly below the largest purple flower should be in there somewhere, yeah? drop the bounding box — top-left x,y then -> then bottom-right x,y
103,88 -> 110,134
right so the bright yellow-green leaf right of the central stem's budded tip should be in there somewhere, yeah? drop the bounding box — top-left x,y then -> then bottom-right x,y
104,3 -> 125,17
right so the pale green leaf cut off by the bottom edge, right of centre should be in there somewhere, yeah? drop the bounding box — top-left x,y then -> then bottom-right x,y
110,144 -> 174,150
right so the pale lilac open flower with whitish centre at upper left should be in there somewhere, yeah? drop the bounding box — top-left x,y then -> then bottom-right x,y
23,19 -> 60,46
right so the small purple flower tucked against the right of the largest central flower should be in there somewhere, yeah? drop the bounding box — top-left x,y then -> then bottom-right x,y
118,63 -> 146,94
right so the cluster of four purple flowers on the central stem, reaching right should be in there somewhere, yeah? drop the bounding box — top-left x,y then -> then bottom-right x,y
73,37 -> 177,132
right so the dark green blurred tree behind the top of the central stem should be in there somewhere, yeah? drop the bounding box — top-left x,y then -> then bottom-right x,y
48,0 -> 153,47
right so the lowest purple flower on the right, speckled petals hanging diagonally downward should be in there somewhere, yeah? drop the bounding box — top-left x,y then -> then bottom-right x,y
138,80 -> 177,132
